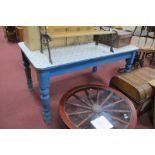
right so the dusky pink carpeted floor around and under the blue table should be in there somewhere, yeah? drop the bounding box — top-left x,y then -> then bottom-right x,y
0,27 -> 152,129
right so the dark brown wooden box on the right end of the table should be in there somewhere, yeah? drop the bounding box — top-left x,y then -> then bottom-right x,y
94,30 -> 132,48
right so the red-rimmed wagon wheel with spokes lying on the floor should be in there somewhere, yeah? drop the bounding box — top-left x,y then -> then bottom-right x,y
59,84 -> 137,129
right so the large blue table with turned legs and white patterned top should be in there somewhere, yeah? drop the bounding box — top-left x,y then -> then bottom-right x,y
18,42 -> 138,123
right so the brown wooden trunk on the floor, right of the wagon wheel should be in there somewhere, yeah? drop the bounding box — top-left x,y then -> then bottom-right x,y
110,67 -> 155,111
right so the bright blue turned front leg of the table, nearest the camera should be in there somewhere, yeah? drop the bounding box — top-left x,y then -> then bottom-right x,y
38,71 -> 51,123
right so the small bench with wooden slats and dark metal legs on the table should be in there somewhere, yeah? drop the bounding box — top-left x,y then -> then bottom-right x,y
39,26 -> 117,64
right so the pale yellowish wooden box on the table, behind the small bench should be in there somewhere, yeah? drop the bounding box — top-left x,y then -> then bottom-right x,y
23,26 -> 94,51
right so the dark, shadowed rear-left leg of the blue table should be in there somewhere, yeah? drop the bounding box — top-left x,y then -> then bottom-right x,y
22,52 -> 33,91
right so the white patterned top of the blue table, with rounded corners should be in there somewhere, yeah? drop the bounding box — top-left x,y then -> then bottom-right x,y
18,42 -> 138,69
